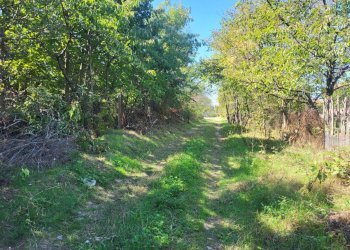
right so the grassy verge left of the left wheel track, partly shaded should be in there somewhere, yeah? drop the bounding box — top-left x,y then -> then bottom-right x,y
0,122 -> 192,248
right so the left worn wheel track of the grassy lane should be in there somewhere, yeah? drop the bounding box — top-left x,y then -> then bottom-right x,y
71,123 -> 209,244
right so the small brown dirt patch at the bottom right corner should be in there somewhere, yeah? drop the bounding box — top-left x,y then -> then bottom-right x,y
327,211 -> 350,248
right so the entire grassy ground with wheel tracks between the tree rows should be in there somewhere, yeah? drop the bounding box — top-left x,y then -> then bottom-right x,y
0,119 -> 350,249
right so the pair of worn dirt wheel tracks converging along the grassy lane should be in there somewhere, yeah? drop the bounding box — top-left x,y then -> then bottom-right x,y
39,120 -> 230,250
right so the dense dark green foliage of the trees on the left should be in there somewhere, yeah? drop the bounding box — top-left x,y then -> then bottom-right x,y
0,0 -> 199,133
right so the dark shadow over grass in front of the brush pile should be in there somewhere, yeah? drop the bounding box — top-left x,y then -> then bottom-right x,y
0,159 -> 115,249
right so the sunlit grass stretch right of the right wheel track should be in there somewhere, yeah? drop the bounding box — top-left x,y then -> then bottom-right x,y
211,124 -> 350,249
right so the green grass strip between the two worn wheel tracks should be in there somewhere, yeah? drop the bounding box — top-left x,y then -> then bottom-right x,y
96,139 -> 205,249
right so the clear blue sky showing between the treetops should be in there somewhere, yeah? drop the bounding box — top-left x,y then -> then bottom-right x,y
153,0 -> 236,105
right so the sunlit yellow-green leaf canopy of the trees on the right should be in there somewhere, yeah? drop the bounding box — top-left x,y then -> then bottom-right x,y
213,0 -> 350,101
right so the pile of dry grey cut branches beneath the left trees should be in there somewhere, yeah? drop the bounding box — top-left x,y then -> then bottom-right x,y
0,114 -> 75,170
